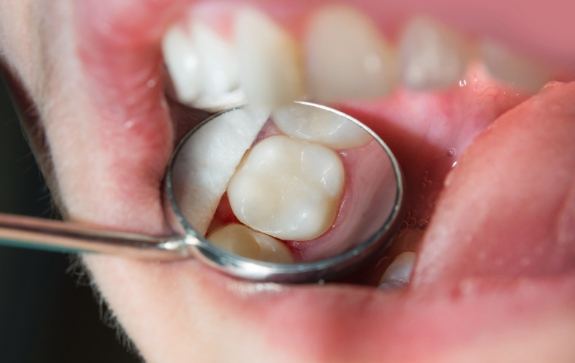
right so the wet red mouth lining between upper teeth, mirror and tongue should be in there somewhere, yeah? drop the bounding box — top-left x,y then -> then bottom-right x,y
339,78 -> 527,229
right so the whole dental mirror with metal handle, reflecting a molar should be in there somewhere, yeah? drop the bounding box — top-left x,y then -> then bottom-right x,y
0,102 -> 403,282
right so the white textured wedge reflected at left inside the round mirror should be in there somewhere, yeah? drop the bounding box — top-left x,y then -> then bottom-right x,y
173,109 -> 268,234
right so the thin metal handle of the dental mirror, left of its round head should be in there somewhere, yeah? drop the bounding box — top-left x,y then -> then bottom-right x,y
0,213 -> 190,261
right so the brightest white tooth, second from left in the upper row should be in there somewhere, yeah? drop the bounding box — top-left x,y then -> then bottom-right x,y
191,20 -> 245,109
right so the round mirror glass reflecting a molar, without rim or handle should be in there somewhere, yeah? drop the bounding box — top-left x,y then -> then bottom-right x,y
173,103 -> 400,264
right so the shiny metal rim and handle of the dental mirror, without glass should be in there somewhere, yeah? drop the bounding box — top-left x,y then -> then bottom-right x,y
0,102 -> 404,283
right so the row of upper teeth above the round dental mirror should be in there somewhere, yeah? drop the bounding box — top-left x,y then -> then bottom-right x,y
163,5 -> 551,110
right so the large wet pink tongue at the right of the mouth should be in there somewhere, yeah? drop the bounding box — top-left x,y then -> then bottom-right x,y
413,83 -> 575,286
